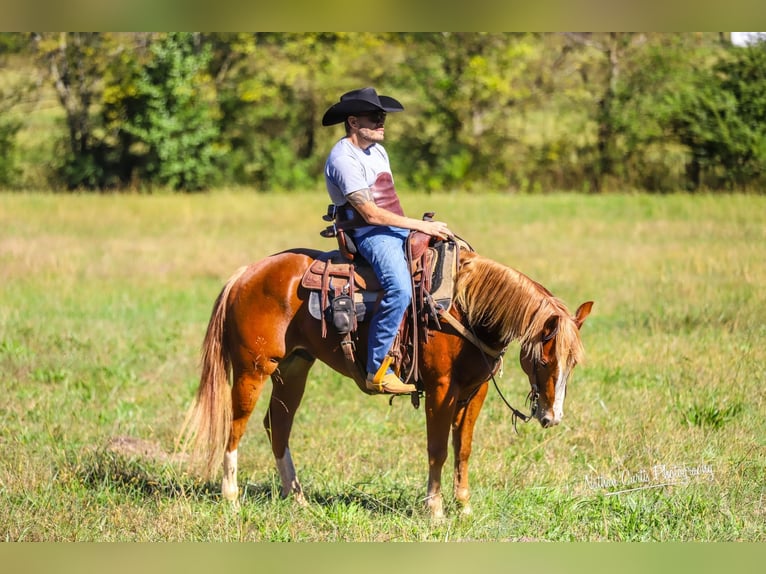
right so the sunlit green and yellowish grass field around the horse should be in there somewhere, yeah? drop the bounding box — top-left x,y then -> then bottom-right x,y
0,192 -> 766,541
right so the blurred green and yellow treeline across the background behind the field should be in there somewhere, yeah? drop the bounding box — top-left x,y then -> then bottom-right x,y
0,32 -> 766,192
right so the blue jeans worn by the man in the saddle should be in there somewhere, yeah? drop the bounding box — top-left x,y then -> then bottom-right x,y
354,227 -> 412,375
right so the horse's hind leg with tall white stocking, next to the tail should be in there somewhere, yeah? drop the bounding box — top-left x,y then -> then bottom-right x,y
221,363 -> 276,502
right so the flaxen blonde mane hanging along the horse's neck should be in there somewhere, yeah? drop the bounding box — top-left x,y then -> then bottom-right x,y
455,253 -> 584,368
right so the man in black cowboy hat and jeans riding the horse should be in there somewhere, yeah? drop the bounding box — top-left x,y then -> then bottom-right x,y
322,88 -> 452,394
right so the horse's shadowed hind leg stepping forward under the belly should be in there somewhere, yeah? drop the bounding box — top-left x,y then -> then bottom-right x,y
263,351 -> 314,504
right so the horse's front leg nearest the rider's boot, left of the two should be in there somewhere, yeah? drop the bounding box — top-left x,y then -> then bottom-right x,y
426,381 -> 455,520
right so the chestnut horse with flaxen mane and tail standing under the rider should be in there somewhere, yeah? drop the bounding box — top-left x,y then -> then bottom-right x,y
181,249 -> 593,518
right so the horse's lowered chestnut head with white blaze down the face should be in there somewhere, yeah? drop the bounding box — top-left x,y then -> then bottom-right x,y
520,301 -> 593,428
